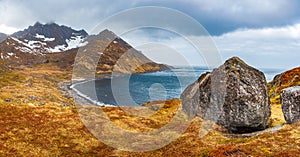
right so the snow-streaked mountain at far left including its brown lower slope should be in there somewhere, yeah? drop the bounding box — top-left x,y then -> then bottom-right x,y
0,22 -> 88,65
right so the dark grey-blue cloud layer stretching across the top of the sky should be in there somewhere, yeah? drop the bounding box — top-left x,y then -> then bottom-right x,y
0,0 -> 300,35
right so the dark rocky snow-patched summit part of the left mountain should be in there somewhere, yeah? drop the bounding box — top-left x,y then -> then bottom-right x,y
11,22 -> 88,53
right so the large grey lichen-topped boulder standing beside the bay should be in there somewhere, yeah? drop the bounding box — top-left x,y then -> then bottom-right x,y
181,57 -> 271,133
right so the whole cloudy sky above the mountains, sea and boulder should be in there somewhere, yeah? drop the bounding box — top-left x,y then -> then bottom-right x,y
0,0 -> 300,70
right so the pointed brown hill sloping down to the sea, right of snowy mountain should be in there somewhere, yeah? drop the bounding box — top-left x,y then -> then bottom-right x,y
77,30 -> 170,74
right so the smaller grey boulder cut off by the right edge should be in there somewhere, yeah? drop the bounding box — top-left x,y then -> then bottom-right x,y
281,86 -> 300,123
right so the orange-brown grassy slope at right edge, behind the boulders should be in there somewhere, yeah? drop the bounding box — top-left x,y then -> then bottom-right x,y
268,67 -> 300,103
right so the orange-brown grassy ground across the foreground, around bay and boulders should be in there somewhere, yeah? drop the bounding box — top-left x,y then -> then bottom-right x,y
0,63 -> 300,156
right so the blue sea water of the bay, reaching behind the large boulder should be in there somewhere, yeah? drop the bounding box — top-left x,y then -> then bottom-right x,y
72,67 -> 283,106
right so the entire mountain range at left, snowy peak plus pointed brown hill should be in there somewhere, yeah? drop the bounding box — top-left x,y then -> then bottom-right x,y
0,22 -> 169,74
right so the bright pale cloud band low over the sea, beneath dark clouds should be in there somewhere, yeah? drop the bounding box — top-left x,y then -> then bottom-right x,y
122,23 -> 300,70
